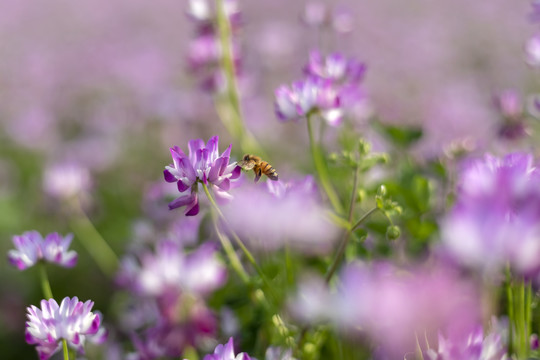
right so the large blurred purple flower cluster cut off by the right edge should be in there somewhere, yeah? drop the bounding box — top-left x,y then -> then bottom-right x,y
442,153 -> 540,274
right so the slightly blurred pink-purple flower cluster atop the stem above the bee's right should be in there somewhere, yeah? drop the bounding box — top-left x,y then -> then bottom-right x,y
275,51 -> 366,126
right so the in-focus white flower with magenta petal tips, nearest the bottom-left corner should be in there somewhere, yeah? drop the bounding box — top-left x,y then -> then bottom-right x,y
26,297 -> 106,360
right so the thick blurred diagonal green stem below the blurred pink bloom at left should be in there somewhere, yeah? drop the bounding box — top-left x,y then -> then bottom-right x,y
70,201 -> 118,276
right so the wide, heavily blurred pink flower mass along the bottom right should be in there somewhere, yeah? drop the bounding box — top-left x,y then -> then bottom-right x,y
291,263 -> 480,359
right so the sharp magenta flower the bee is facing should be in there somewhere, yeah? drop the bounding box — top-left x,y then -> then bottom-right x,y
163,136 -> 241,216
